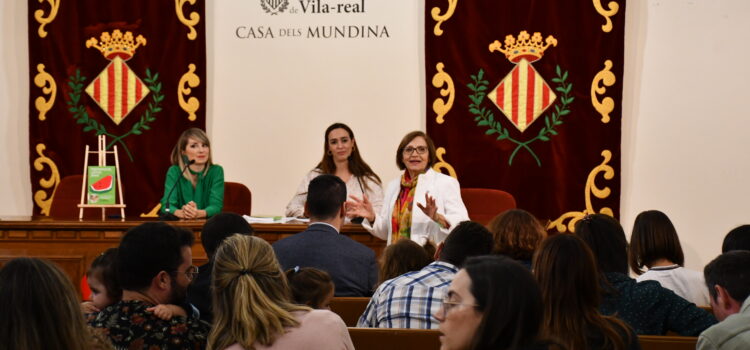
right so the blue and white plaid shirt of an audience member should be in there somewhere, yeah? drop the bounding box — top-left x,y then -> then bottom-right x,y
357,261 -> 458,329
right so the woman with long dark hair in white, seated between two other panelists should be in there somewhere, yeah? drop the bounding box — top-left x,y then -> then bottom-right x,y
285,123 -> 383,217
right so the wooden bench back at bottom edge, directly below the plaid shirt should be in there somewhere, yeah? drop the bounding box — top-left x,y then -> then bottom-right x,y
349,328 -> 440,350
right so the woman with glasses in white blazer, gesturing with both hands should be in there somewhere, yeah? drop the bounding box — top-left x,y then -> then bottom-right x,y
347,131 -> 469,245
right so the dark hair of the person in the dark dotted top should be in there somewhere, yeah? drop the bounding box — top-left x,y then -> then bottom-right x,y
575,214 -> 628,274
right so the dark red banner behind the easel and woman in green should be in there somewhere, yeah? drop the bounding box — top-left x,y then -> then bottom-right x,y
28,0 -> 206,217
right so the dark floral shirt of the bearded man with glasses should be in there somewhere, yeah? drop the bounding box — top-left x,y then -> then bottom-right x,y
88,300 -> 209,350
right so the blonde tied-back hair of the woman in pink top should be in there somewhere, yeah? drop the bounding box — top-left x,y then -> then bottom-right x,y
208,234 -> 311,350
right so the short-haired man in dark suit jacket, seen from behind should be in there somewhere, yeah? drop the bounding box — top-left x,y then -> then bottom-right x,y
273,174 -> 378,297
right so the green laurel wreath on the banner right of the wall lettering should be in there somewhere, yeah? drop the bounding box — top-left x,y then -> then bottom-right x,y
466,66 -> 573,167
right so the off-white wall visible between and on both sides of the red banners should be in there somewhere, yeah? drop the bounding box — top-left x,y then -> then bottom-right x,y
0,0 -> 750,269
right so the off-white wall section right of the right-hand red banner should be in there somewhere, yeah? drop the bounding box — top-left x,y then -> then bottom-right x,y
621,0 -> 750,270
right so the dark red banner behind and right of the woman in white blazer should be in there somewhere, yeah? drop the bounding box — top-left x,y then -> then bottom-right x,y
425,0 -> 625,231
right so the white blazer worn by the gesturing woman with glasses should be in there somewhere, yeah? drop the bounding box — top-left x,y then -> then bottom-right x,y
362,169 -> 469,245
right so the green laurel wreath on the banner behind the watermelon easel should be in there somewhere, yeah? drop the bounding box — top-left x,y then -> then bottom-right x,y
66,68 -> 164,162
